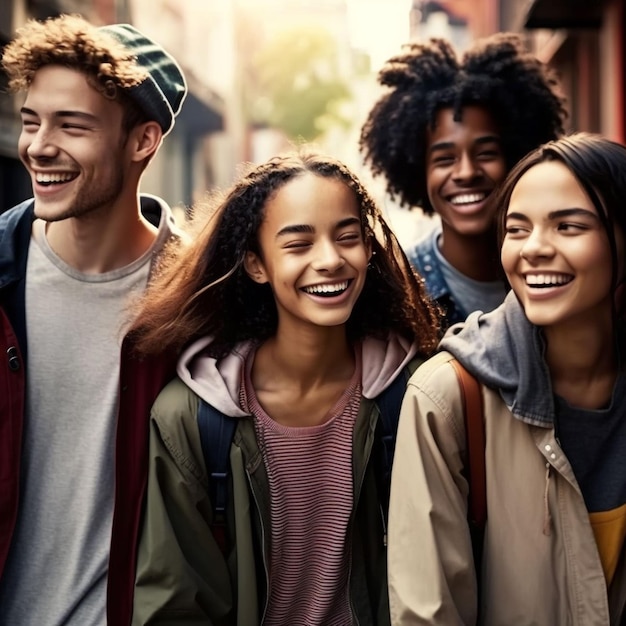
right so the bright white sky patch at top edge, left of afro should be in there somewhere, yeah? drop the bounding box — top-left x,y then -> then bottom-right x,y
347,0 -> 413,71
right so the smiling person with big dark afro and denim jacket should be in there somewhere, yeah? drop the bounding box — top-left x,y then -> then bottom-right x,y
360,33 -> 566,330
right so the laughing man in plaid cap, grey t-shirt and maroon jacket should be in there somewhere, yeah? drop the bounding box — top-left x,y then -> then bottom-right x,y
0,16 -> 187,626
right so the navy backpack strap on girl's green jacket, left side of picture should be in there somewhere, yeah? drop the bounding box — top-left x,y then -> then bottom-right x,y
198,398 -> 237,553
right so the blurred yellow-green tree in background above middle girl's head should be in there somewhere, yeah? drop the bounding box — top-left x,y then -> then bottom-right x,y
244,25 -> 351,141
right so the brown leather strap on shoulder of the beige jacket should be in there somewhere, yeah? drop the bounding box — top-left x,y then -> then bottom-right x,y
450,359 -> 487,528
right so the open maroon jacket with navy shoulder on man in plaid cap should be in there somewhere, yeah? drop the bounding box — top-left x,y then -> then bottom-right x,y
0,197 -> 176,626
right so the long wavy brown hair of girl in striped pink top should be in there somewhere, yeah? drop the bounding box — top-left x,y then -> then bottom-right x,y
131,146 -> 439,358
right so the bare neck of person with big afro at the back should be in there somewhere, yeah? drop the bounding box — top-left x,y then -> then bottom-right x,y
439,224 -> 500,282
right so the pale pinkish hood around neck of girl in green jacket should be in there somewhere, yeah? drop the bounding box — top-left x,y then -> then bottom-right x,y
177,334 -> 418,417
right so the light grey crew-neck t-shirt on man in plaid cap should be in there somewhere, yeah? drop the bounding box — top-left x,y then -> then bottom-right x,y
0,220 -> 165,626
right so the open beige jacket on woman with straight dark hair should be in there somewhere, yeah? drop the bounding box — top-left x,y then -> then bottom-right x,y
388,352 -> 626,626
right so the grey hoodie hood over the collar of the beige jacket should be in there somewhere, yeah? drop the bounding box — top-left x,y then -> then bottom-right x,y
439,291 -> 554,427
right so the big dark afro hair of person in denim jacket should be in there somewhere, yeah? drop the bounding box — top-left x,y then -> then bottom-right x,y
359,33 -> 567,215
